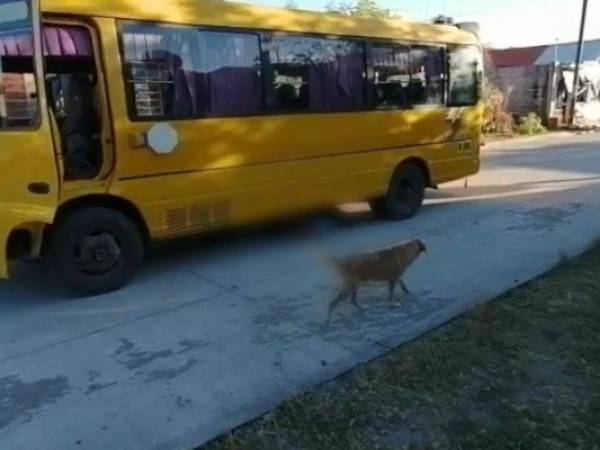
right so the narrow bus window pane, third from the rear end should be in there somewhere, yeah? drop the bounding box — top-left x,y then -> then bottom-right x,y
371,43 -> 410,108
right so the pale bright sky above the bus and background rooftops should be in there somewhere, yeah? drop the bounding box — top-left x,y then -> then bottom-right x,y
233,0 -> 600,48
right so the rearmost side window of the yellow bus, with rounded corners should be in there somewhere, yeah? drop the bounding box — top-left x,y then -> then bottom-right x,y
448,45 -> 483,106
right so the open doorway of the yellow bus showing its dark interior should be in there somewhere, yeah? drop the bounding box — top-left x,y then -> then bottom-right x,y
43,25 -> 103,180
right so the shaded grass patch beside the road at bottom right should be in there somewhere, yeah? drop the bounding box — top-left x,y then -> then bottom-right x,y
202,247 -> 600,450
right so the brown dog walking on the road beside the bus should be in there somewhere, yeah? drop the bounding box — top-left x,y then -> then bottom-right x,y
327,239 -> 427,324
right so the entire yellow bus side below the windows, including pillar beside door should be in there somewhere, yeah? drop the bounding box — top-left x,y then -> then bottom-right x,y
97,19 -> 480,241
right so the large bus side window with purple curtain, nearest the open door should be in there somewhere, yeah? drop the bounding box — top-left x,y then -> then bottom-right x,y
121,23 -> 263,119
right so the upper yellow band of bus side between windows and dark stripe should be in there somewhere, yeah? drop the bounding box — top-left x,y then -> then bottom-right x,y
109,107 -> 474,178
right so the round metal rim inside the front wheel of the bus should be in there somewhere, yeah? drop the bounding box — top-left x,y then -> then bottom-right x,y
73,232 -> 121,275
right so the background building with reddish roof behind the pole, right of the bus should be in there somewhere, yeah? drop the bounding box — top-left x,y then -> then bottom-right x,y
486,40 -> 600,127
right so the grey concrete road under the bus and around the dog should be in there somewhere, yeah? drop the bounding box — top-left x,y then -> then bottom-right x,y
0,135 -> 600,450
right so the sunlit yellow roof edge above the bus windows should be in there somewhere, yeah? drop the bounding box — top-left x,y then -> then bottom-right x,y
41,0 -> 479,44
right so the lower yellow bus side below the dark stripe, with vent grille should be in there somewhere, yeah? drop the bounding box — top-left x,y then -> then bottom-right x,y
112,137 -> 472,238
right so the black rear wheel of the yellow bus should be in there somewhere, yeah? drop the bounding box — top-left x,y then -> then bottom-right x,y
370,163 -> 426,220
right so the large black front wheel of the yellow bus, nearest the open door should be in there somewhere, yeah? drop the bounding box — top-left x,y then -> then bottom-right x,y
46,207 -> 144,295
